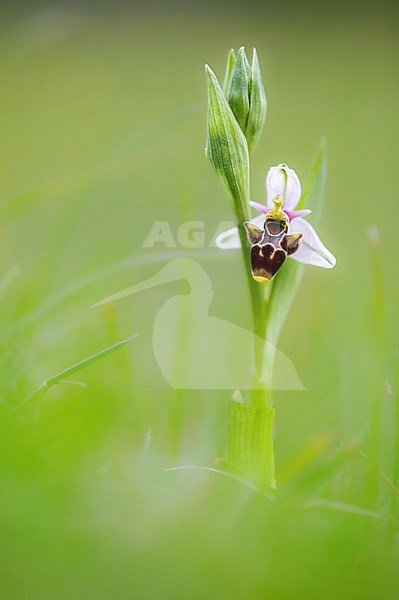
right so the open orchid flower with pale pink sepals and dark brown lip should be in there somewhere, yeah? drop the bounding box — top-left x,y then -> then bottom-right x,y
216,163 -> 336,282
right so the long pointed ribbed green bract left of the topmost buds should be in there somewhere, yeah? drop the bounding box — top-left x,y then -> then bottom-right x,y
205,65 -> 249,223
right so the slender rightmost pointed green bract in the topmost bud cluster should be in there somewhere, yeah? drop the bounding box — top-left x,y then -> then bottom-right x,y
245,48 -> 267,150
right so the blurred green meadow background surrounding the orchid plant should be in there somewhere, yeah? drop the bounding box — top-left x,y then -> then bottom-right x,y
0,1 -> 399,600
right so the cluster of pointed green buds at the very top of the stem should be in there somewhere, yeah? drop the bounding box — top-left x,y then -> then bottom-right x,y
225,47 -> 267,150
